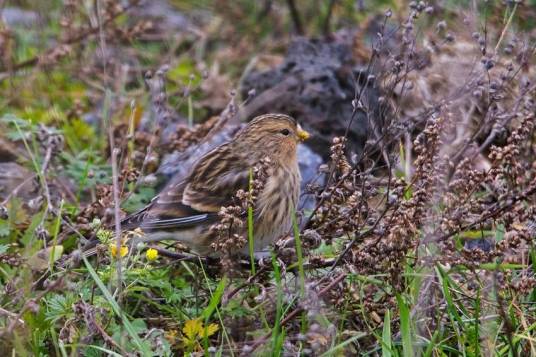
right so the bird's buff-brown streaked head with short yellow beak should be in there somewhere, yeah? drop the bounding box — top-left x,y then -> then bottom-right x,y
234,114 -> 309,164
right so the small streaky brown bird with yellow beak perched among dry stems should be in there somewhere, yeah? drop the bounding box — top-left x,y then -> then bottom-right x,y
121,114 -> 309,255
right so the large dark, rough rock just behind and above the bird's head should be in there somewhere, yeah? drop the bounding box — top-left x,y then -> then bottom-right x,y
240,38 -> 382,158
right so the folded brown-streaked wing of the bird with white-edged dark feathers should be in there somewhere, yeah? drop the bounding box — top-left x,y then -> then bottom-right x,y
121,145 -> 249,231
